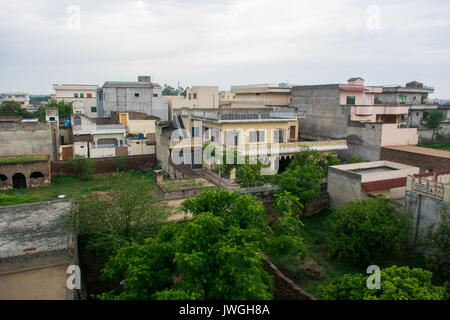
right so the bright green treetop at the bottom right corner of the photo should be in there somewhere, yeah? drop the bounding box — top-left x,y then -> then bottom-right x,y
320,266 -> 447,300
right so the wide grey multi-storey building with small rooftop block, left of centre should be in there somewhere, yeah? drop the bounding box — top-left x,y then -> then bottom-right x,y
97,76 -> 169,120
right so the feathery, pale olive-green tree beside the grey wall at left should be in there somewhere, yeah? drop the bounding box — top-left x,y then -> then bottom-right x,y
70,172 -> 168,258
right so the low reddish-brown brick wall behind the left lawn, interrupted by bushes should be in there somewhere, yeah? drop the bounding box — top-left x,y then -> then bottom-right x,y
51,154 -> 156,175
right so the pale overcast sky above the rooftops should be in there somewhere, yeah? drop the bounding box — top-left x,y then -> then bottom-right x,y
0,0 -> 450,98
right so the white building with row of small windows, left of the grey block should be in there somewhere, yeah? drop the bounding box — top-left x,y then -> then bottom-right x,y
52,84 -> 98,118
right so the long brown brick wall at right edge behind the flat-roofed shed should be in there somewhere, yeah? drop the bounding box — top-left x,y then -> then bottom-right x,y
380,148 -> 450,173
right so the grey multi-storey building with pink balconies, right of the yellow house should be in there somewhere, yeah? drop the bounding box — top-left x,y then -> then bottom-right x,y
291,78 -> 418,161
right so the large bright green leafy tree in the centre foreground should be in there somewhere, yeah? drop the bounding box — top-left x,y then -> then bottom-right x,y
101,189 -> 273,300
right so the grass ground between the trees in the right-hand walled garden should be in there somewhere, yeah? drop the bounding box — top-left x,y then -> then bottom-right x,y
273,210 -> 425,297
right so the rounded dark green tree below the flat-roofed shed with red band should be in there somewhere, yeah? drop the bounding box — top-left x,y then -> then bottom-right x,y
327,198 -> 410,266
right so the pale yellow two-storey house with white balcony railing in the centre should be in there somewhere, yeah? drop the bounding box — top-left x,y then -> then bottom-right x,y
171,107 -> 347,170
